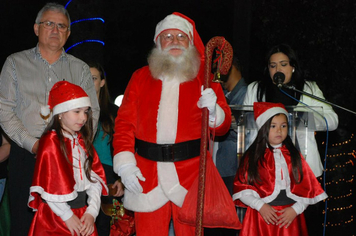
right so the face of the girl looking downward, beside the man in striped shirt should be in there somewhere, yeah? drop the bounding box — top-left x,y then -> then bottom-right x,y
59,107 -> 89,134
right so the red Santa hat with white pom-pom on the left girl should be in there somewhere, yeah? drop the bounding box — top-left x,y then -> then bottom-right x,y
41,81 -> 91,116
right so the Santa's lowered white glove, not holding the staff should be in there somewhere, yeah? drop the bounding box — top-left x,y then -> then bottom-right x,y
118,163 -> 146,194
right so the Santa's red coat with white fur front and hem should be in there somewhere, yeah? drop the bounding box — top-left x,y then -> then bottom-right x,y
113,66 -> 231,212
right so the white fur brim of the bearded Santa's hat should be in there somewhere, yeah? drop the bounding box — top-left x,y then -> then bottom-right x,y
153,14 -> 193,43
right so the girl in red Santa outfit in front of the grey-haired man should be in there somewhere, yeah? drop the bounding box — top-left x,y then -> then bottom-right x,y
28,81 -> 107,236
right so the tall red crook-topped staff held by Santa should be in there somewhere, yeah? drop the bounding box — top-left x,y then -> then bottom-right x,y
195,36 -> 233,236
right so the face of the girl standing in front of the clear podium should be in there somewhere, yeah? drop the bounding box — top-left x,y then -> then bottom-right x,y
268,114 -> 288,146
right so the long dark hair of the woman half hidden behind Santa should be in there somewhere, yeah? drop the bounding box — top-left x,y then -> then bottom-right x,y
88,62 -> 115,142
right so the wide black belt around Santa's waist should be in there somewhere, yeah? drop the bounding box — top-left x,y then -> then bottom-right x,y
135,139 -> 200,162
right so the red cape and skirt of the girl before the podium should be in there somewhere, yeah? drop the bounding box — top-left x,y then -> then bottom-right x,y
233,146 -> 327,236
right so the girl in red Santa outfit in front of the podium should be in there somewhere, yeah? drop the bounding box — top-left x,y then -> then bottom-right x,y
233,102 -> 327,236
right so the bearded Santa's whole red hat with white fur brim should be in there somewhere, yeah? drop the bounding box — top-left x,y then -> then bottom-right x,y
153,12 -> 205,57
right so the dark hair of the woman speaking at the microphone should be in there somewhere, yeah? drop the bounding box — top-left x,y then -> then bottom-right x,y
257,44 -> 305,105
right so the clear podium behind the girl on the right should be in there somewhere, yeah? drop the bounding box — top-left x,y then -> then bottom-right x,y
230,105 -> 323,159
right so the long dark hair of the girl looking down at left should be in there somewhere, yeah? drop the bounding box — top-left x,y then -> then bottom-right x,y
43,108 -> 94,182
